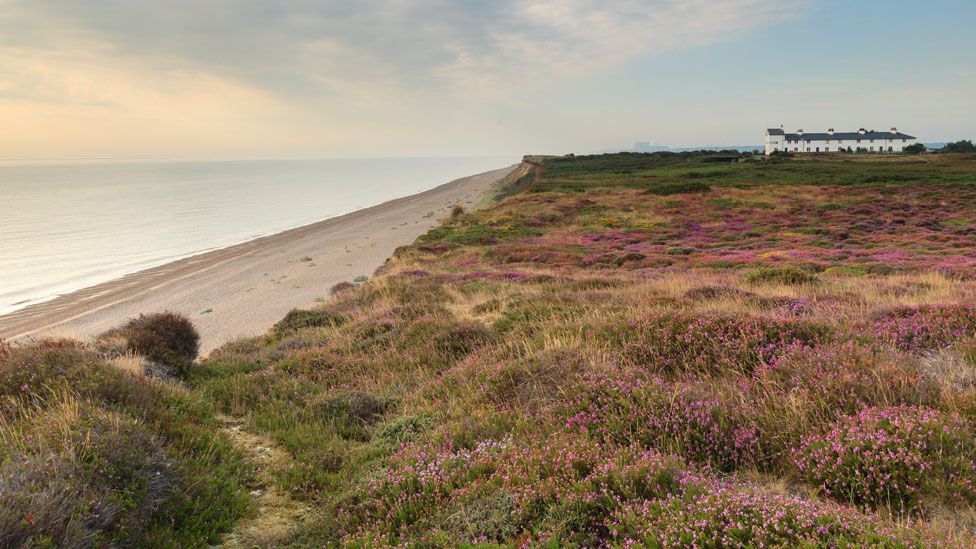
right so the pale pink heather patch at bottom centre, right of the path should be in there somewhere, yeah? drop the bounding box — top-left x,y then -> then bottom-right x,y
344,435 -> 702,546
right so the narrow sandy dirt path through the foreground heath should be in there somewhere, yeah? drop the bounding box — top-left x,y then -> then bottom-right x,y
217,415 -> 312,547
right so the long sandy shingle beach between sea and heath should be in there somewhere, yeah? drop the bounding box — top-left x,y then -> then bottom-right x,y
0,167 -> 512,355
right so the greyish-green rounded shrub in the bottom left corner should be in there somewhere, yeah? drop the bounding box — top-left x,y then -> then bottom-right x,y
0,395 -> 174,547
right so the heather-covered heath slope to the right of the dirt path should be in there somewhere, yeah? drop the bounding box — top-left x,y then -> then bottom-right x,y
192,150 -> 976,545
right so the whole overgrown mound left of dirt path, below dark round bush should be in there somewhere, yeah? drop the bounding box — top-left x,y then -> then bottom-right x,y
0,340 -> 251,546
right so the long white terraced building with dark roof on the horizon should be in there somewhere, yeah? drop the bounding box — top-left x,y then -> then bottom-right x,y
766,127 -> 916,154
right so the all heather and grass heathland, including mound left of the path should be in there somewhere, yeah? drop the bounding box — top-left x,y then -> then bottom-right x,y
0,152 -> 976,547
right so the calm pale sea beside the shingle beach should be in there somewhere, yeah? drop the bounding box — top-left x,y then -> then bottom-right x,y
0,157 -> 517,314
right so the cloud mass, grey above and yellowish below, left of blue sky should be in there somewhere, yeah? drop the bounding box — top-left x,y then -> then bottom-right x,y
0,0 -> 805,154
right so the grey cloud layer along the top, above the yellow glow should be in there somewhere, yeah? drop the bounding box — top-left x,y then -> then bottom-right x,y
0,0 -> 796,98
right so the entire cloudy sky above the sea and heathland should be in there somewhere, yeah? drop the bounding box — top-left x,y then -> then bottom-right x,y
0,0 -> 976,157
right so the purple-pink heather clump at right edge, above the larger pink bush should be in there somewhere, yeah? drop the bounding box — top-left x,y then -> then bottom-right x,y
874,305 -> 976,352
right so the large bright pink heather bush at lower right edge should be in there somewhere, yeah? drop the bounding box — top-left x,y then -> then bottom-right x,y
793,406 -> 976,510
